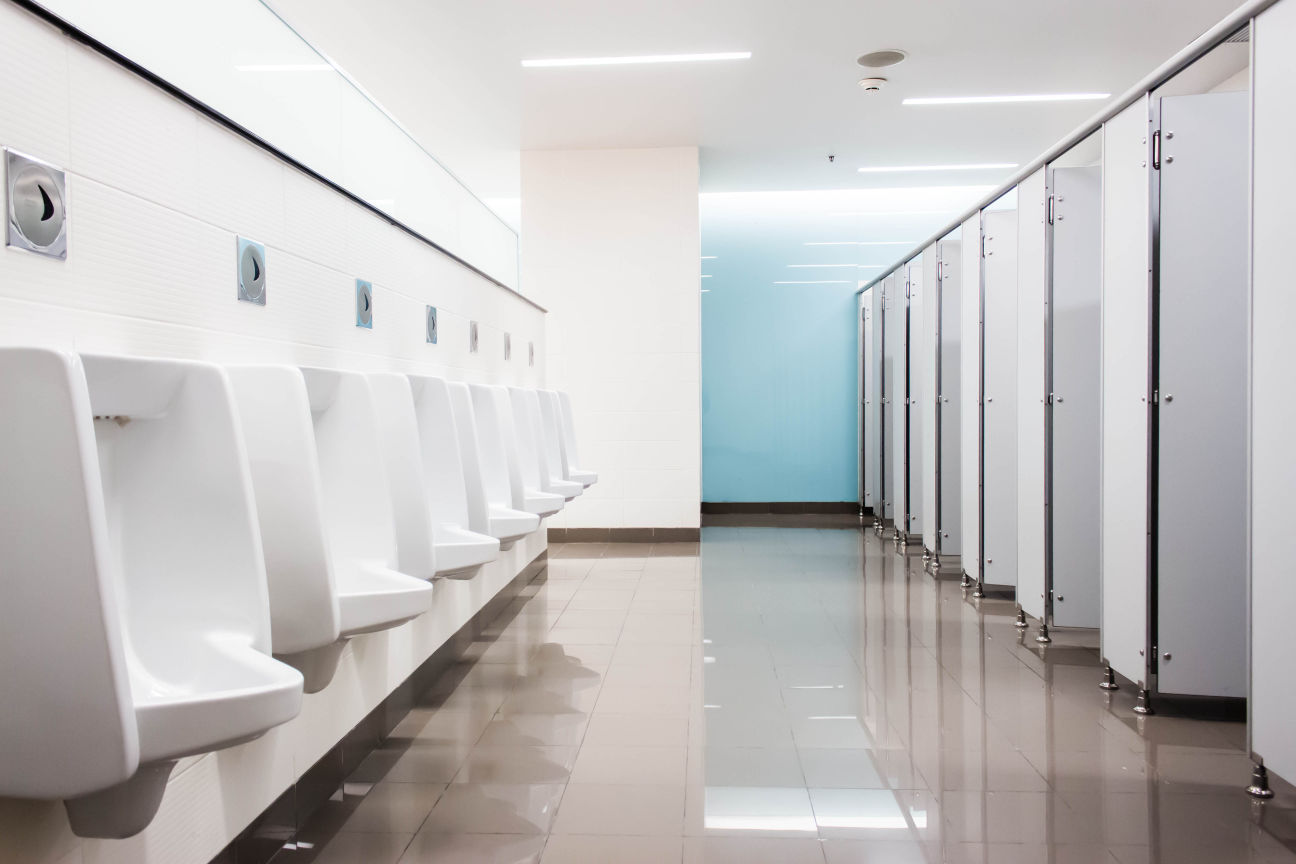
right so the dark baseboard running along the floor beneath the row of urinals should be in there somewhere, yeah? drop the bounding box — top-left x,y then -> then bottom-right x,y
211,551 -> 548,864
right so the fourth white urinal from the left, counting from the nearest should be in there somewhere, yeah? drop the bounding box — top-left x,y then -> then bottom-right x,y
446,381 -> 540,549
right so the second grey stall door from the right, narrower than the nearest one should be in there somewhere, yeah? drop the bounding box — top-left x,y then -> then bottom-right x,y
1048,167 -> 1103,627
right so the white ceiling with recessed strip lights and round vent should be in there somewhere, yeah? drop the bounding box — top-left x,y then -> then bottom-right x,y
266,0 -> 1238,239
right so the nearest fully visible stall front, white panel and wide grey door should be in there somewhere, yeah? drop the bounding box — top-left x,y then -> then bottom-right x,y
1102,54 -> 1251,712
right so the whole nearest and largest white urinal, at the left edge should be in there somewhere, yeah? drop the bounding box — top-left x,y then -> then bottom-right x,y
0,348 -> 302,837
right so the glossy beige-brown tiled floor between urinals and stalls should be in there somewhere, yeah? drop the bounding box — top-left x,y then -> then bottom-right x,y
292,527 -> 1296,864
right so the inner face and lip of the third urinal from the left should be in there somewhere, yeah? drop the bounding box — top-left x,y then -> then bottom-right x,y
410,376 -> 499,579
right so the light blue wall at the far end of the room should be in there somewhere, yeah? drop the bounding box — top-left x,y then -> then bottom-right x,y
701,277 -> 859,501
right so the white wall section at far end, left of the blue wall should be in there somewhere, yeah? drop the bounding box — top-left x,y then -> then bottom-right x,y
521,148 -> 701,529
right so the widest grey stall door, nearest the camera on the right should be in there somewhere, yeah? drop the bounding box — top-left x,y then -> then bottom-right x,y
1155,92 -> 1244,697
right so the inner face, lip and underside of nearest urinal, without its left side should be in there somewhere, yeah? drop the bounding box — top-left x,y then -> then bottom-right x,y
65,356 -> 302,837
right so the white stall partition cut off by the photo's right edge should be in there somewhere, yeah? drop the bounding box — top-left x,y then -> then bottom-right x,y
1249,0 -> 1296,780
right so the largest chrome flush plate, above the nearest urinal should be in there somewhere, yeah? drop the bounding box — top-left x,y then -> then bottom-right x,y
5,150 -> 67,260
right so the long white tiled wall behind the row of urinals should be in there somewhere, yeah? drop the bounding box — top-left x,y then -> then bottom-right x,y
0,3 -> 546,864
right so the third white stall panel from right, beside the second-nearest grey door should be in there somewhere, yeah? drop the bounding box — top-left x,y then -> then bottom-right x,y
1016,168 -> 1048,620
